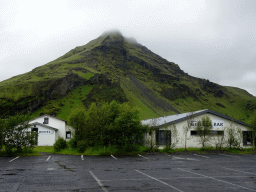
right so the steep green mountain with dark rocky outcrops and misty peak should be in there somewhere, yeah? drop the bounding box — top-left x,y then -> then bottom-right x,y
0,31 -> 256,122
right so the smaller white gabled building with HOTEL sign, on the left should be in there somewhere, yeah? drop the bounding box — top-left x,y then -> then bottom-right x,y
29,114 -> 73,146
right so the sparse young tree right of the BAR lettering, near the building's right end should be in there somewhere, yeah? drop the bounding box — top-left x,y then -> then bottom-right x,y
225,122 -> 243,149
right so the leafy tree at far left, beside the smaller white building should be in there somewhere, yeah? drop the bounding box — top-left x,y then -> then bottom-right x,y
4,115 -> 38,154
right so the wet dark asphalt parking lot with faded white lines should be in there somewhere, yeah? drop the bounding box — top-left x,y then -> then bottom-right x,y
0,153 -> 256,192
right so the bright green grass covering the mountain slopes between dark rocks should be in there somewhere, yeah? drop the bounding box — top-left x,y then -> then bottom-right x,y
0,29 -> 256,123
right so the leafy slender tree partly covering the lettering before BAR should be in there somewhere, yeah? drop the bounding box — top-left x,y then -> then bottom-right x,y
195,115 -> 212,148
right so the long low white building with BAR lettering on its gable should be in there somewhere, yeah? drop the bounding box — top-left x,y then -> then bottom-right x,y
141,109 -> 252,149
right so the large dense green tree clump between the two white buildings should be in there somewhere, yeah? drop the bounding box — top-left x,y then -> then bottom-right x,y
70,101 -> 146,150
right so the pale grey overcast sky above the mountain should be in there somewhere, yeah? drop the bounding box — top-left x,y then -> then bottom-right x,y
0,0 -> 256,96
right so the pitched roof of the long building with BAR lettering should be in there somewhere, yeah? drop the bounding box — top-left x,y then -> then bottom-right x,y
141,109 -> 249,128
